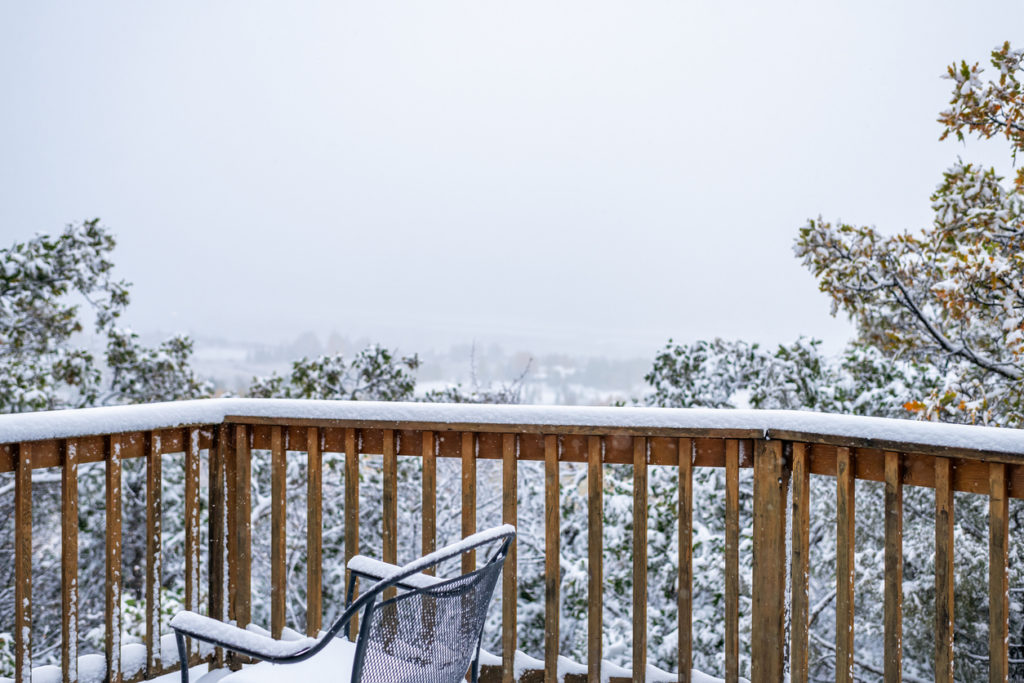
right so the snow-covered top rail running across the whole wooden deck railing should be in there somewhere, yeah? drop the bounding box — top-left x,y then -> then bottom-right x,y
0,398 -> 1024,462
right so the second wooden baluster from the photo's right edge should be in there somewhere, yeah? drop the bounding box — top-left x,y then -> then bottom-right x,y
935,458 -> 953,683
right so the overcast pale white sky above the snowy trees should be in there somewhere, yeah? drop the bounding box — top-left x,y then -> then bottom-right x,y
0,0 -> 1024,355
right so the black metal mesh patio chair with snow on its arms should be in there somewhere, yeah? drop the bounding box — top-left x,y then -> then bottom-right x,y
170,524 -> 515,683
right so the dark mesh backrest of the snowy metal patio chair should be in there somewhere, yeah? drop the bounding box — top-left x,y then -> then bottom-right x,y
352,538 -> 511,683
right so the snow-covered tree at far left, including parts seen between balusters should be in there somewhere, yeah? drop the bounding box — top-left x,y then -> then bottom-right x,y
0,225 -> 212,675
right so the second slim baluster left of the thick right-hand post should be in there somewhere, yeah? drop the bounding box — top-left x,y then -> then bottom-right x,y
677,438 -> 693,683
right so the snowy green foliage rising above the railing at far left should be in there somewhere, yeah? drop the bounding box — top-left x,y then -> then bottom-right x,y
0,219 -> 211,413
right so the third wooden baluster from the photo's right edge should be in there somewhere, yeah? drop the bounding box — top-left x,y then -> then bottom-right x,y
884,451 -> 903,683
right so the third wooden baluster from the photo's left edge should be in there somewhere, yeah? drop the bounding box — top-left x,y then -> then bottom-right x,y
105,434 -> 123,683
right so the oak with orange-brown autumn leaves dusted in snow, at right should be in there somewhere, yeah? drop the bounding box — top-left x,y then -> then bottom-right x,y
795,43 -> 1024,427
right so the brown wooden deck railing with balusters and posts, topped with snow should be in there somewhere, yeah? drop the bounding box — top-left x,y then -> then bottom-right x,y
0,401 -> 1024,683
